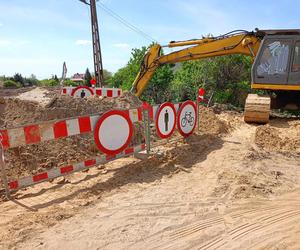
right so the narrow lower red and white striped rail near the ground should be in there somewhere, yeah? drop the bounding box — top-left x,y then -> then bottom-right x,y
8,144 -> 145,190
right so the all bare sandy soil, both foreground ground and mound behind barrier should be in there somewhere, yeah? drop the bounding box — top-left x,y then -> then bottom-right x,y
0,88 -> 300,249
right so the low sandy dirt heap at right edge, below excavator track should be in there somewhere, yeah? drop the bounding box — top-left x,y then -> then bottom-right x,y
255,120 -> 300,152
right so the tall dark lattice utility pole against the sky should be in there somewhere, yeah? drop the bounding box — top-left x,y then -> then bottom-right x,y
79,0 -> 104,87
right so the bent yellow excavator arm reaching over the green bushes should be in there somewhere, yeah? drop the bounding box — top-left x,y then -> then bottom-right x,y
131,31 -> 262,96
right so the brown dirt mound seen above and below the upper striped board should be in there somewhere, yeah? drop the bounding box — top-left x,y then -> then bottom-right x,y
2,88 -> 142,180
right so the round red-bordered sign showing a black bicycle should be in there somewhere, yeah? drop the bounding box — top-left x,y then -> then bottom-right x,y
177,101 -> 197,137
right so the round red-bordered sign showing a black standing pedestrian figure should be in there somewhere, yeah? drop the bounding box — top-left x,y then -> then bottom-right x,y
155,102 -> 176,139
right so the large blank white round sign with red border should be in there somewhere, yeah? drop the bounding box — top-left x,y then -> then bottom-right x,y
94,110 -> 133,155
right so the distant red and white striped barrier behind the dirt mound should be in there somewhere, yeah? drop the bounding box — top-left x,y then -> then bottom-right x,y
61,86 -> 122,97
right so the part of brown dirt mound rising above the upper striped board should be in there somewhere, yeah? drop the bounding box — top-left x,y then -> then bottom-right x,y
2,88 -> 141,128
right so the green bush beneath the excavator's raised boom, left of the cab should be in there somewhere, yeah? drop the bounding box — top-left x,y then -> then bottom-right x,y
172,55 -> 251,106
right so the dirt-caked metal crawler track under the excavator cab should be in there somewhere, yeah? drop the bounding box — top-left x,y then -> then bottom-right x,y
244,94 -> 271,123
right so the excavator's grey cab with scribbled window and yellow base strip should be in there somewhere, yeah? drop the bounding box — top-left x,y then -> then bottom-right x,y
252,30 -> 300,87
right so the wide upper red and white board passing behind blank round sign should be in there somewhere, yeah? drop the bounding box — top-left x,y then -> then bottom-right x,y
0,109 -> 142,149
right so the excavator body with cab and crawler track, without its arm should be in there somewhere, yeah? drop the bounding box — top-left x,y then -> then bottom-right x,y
244,30 -> 300,123
